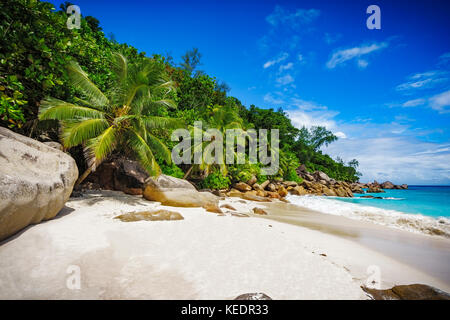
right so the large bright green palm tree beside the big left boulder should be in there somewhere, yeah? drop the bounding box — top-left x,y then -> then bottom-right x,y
39,53 -> 180,184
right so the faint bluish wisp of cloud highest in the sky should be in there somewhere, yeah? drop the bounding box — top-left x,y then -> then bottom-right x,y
266,6 -> 320,29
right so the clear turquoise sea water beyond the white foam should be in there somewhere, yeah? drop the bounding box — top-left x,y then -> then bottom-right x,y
334,186 -> 450,218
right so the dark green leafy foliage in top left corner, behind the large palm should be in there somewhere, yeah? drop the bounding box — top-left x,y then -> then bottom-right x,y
0,0 -> 144,134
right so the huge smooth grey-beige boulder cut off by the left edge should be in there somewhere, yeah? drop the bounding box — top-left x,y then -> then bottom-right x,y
0,127 -> 78,240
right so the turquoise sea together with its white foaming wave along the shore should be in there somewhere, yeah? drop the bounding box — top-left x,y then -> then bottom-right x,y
287,186 -> 450,238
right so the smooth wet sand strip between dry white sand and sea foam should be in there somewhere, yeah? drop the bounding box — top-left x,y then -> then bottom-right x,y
265,203 -> 450,287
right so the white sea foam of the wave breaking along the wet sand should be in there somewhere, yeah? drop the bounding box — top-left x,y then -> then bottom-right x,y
286,195 -> 450,238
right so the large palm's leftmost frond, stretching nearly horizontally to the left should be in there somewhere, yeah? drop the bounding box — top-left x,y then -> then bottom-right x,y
39,98 -> 104,120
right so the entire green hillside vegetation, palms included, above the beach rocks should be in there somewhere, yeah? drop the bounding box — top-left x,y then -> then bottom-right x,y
0,0 -> 359,189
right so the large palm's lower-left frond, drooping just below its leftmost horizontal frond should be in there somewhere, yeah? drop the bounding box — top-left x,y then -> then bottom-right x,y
61,119 -> 108,148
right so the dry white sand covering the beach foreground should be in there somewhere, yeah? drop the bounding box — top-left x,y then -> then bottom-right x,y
0,192 -> 448,299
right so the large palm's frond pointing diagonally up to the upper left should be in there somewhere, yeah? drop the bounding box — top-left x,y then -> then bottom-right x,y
67,61 -> 109,107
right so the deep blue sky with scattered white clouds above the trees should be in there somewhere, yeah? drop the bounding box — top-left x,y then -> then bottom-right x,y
52,0 -> 450,184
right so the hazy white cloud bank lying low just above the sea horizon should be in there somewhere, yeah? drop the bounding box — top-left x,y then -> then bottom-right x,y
323,136 -> 450,184
